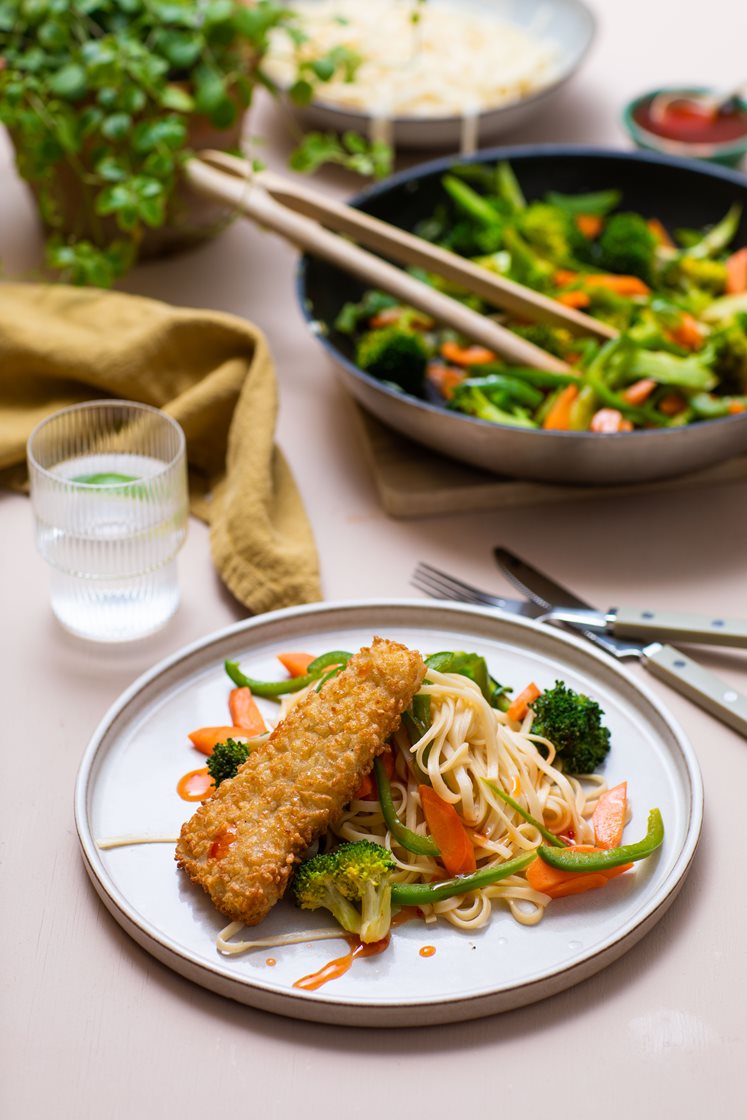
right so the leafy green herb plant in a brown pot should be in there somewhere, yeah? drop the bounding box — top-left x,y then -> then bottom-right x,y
0,0 -> 385,287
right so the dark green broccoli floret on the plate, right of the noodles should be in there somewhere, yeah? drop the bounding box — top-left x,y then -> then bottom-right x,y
530,681 -> 609,774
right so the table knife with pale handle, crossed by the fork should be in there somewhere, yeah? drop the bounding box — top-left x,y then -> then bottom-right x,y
494,548 -> 747,736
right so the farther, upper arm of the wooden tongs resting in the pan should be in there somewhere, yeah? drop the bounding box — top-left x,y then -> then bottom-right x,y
199,150 -> 617,340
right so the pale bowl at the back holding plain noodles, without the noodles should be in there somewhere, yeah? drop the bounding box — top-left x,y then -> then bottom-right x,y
279,0 -> 595,151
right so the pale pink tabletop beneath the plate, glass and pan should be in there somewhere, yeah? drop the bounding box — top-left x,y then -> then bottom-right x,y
0,0 -> 747,1120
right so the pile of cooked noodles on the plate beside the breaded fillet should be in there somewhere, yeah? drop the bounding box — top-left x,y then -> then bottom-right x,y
335,669 -> 606,931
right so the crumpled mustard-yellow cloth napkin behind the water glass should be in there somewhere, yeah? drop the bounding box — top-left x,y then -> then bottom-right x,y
0,283 -> 320,613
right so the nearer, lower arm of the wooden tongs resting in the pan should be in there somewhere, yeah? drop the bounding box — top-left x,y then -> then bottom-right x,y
184,157 -> 573,373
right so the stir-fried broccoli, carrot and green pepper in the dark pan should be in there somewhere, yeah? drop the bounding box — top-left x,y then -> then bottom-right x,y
335,164 -> 747,432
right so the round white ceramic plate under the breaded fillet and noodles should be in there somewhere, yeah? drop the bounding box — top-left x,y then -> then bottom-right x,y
75,600 -> 702,1026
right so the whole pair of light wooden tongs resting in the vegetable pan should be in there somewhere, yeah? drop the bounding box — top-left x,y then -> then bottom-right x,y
185,151 -> 616,373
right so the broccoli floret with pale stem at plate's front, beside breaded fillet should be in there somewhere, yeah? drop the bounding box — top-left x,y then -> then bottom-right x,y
292,840 -> 396,942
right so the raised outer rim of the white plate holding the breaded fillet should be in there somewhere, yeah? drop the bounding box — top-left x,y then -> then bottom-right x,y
74,597 -> 703,1027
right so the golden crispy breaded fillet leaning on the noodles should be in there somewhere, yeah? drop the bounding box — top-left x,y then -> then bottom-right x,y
176,637 -> 426,925
